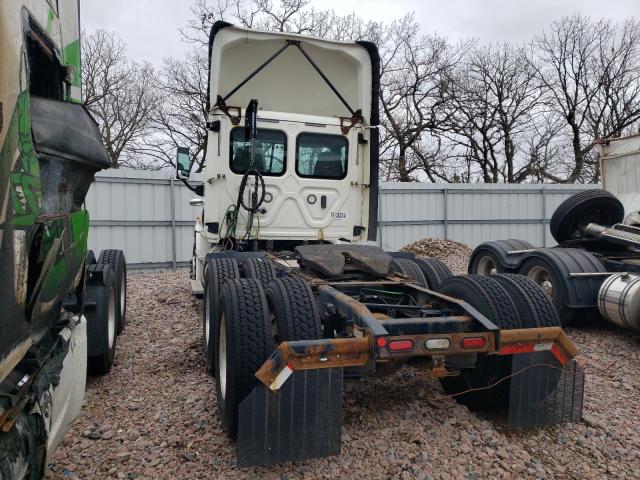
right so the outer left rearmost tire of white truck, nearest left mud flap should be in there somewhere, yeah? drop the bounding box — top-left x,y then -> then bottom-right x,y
215,279 -> 275,440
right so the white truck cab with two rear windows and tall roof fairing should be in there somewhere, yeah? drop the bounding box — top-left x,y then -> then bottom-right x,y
182,22 -> 379,292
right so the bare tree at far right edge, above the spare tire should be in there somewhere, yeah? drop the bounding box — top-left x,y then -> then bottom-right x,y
532,15 -> 640,183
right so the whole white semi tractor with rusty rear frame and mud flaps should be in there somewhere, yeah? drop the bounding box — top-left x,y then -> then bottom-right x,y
176,22 -> 584,466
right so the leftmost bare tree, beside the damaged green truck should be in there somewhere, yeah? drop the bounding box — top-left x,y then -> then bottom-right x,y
82,30 -> 159,168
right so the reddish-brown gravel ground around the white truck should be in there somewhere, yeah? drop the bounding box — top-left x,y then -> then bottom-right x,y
47,273 -> 640,480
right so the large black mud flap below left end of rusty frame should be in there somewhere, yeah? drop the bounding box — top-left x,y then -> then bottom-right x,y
238,368 -> 342,467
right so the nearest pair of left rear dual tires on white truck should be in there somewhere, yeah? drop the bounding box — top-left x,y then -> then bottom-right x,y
214,277 -> 322,439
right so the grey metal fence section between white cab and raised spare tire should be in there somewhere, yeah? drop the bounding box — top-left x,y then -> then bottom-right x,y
378,183 -> 599,250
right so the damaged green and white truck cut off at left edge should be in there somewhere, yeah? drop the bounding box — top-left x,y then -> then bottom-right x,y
0,0 -> 126,480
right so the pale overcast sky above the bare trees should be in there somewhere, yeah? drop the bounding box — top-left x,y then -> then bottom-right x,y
81,0 -> 640,65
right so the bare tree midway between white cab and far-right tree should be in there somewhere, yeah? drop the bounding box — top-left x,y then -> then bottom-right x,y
441,44 -> 542,183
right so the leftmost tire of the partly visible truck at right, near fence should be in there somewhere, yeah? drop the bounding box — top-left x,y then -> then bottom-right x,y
468,238 -> 534,275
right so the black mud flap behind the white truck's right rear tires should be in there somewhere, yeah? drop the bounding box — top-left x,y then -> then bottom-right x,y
509,351 -> 584,429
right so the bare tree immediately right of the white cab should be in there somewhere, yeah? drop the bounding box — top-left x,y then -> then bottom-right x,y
380,15 -> 467,182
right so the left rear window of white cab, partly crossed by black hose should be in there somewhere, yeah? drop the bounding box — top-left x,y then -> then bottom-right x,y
230,127 -> 287,176
